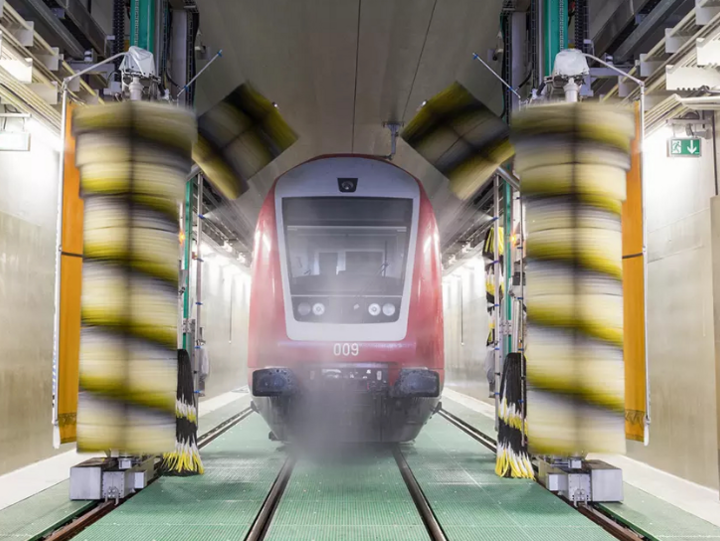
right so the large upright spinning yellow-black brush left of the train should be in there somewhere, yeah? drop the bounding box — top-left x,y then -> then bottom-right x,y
73,102 -> 196,455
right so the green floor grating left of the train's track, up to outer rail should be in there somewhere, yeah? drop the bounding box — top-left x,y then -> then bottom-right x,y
75,415 -> 285,541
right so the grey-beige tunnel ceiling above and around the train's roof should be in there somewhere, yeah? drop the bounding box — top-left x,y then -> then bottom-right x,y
196,0 -> 502,249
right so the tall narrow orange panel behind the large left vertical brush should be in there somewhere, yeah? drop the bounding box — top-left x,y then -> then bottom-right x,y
58,104 -> 84,443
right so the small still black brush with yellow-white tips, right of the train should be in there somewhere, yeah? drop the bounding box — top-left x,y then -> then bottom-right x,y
495,353 -> 535,479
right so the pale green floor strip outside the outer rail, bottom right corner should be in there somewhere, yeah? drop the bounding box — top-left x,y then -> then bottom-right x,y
600,483 -> 720,541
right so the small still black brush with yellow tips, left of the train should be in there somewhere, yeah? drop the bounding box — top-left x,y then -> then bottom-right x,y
161,349 -> 205,476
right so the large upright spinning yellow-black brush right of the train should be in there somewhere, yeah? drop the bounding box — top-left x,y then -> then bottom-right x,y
513,103 -> 635,457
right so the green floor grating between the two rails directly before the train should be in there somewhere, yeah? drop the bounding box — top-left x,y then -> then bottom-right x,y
266,448 -> 429,541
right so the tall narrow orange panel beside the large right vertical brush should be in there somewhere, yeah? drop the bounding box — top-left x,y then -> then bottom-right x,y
622,103 -> 646,441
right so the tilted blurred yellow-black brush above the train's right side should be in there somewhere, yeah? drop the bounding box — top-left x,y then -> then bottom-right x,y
401,83 -> 513,199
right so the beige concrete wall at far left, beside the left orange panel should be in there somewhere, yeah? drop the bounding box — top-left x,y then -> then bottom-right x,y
0,121 -> 59,474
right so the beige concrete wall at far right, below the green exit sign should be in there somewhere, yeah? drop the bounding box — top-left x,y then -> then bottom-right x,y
628,130 -> 718,488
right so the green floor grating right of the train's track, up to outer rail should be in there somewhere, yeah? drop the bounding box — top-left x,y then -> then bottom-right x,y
403,416 -> 613,541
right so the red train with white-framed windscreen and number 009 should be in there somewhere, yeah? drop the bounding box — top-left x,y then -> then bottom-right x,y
248,155 -> 444,443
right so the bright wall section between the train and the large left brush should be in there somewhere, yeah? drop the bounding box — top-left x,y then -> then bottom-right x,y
202,255 -> 250,398
